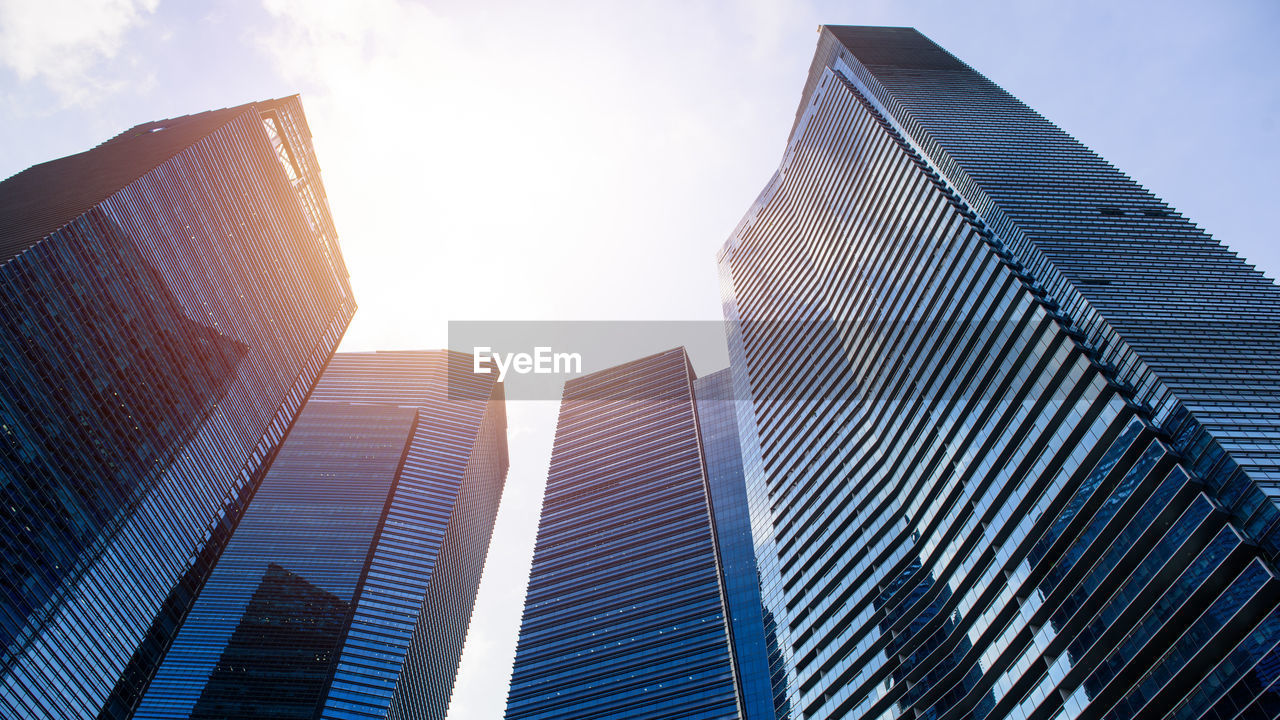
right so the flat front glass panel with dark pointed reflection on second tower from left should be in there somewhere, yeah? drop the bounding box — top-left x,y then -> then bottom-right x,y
172,402 -> 416,720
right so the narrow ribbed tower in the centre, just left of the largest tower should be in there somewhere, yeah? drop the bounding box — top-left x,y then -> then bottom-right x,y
507,348 -> 773,720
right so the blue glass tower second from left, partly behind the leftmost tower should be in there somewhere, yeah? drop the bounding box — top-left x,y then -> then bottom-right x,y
134,351 -> 507,720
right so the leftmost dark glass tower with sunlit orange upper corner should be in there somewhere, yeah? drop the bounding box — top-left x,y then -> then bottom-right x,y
0,97 -> 356,717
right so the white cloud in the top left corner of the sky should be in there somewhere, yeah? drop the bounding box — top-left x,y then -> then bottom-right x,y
0,0 -> 159,105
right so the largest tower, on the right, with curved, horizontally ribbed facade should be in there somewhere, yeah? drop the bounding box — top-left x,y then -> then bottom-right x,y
721,27 -> 1280,719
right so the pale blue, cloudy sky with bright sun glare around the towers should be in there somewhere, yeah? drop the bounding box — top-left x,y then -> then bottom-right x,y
0,0 -> 1280,720
